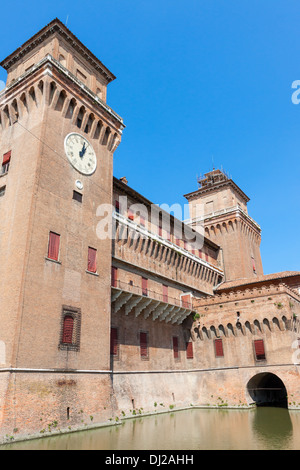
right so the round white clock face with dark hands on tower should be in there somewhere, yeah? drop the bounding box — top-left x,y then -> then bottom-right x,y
65,132 -> 97,175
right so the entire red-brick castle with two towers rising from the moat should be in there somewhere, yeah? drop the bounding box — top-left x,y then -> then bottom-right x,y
0,19 -> 300,442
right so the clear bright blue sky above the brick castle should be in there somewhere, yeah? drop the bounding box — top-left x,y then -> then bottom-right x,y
0,0 -> 300,274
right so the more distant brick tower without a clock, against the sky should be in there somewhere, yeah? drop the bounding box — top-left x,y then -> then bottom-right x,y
185,170 -> 263,280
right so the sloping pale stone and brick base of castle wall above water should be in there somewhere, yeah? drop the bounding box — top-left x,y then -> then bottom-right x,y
0,365 -> 300,443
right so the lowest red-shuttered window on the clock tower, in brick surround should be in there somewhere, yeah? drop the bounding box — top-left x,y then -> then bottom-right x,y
59,306 -> 81,351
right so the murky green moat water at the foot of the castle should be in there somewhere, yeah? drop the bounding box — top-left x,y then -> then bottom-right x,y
0,408 -> 300,450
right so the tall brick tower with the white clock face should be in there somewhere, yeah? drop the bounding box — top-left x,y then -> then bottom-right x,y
0,19 -> 124,434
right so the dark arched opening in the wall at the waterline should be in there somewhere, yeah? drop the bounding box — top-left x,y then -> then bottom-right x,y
247,372 -> 288,408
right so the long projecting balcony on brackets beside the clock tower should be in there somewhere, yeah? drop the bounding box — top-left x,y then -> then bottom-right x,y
111,281 -> 196,325
